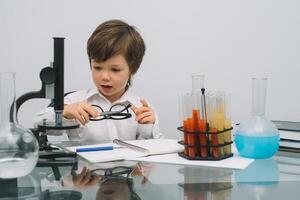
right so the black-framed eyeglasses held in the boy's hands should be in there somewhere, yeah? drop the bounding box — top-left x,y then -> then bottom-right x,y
90,101 -> 131,121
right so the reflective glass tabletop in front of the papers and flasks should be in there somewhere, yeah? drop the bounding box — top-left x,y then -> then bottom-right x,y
0,142 -> 300,200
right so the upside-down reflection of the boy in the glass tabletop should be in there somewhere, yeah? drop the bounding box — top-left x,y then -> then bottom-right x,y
63,163 -> 153,200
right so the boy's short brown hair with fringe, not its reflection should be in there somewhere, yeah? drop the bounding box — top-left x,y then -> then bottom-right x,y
87,20 -> 146,85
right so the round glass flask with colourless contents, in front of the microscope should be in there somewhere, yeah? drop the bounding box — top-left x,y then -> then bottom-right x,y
0,72 -> 39,179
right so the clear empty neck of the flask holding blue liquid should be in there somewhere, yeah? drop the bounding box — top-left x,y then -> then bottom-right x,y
252,78 -> 267,117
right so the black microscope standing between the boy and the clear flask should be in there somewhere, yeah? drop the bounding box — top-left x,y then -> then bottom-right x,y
16,38 -> 79,179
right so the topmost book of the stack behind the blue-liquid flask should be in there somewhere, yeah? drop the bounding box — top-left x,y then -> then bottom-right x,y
272,120 -> 300,142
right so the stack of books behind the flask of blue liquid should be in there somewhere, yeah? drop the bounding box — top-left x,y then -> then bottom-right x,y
272,120 -> 300,152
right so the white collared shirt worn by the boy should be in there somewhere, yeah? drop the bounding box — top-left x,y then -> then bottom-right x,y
34,88 -> 162,141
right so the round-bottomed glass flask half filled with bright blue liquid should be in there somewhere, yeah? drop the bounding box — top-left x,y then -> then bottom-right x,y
235,78 -> 279,158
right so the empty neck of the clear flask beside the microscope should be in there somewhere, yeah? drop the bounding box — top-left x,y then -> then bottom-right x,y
0,72 -> 16,124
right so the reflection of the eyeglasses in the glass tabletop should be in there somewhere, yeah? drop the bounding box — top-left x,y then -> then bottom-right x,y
91,166 -> 133,177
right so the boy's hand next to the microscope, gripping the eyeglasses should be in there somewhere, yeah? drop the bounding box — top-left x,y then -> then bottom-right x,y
63,101 -> 100,125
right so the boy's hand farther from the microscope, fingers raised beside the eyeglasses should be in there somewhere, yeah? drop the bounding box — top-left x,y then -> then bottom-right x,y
130,99 -> 155,124
